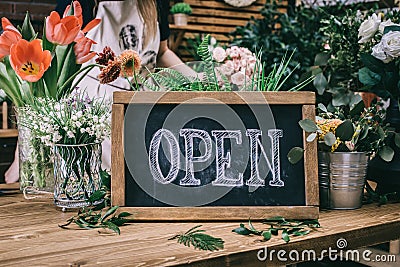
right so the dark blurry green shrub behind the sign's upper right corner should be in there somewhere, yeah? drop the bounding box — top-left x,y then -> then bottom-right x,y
230,1 -> 325,90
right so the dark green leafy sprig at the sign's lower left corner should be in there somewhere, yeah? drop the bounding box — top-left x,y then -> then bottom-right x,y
59,170 -> 133,234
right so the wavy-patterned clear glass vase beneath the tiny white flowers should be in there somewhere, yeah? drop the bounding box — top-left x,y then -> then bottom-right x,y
54,143 -> 101,208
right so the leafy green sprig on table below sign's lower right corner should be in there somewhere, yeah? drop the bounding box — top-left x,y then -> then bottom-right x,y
232,219 -> 321,243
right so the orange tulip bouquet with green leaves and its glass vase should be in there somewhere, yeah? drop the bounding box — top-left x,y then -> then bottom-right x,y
0,1 -> 100,191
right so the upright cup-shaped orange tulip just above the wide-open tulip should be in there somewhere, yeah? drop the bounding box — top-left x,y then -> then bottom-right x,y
46,11 -> 81,45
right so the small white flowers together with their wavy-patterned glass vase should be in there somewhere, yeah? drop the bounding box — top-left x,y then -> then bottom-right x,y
27,91 -> 111,207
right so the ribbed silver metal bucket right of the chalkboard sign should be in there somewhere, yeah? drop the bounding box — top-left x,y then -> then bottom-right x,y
318,152 -> 368,209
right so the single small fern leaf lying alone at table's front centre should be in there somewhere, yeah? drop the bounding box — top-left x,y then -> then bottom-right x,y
168,225 -> 224,251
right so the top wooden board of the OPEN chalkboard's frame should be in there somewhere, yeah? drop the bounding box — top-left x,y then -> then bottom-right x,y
113,91 -> 315,105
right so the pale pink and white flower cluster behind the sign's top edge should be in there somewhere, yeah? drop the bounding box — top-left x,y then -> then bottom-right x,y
212,46 -> 257,88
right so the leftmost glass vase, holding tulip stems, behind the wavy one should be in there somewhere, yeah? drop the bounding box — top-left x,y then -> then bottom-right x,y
16,107 -> 54,192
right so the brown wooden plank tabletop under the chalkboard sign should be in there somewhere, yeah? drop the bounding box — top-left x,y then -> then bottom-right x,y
0,192 -> 400,267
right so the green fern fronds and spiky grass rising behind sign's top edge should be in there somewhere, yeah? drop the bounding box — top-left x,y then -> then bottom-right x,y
142,35 -> 314,91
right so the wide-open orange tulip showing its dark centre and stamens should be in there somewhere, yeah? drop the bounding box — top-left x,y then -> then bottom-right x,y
10,39 -> 51,82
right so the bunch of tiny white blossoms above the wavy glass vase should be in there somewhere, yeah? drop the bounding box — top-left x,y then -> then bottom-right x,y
24,92 -> 111,146
